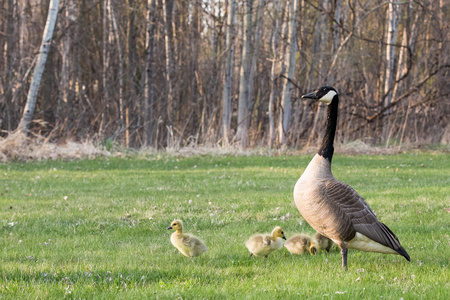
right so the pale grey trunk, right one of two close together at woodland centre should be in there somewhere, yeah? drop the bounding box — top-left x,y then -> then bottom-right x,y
236,0 -> 253,148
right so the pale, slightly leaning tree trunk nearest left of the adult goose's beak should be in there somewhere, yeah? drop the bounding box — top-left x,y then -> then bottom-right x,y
278,0 -> 300,145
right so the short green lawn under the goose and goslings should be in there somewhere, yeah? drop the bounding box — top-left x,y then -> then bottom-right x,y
0,153 -> 450,299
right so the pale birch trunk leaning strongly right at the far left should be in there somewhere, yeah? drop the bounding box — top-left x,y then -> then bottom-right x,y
18,0 -> 59,134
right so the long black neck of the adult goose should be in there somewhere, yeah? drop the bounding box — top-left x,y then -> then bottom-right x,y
318,95 -> 339,163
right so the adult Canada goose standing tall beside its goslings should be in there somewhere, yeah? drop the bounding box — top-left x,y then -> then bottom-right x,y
294,86 -> 410,269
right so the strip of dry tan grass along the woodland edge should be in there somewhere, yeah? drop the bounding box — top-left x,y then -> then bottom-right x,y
0,132 -> 450,162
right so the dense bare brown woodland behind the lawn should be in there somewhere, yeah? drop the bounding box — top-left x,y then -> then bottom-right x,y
0,0 -> 450,149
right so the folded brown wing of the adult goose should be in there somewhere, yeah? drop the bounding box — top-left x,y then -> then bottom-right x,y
325,179 -> 409,259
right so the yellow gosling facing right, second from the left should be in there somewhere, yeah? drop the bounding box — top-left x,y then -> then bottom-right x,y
245,226 -> 286,257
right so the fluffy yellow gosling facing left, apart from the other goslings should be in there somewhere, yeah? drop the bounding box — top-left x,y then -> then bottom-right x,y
167,220 -> 208,257
